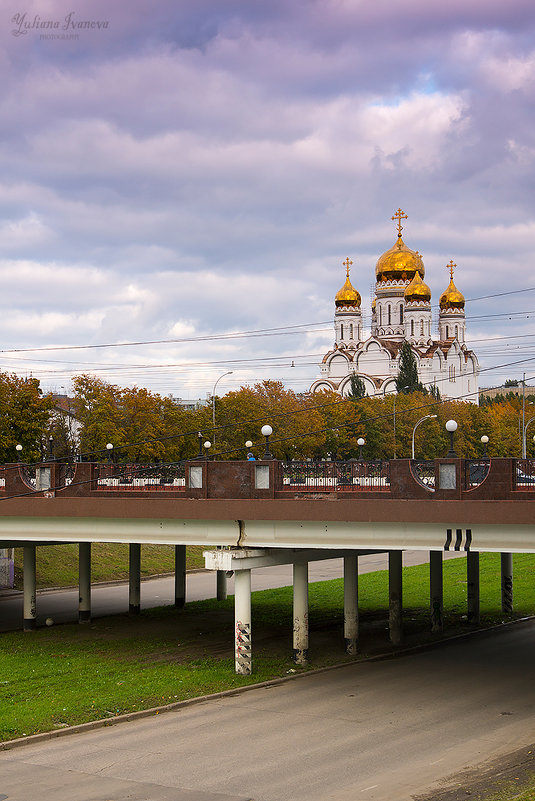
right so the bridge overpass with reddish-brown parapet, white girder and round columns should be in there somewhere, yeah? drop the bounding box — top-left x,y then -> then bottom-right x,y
0,458 -> 535,673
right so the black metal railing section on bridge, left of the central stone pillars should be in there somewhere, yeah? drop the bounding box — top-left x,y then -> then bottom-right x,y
96,462 -> 186,491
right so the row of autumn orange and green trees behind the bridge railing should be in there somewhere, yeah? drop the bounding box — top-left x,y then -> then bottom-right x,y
0,373 -> 535,462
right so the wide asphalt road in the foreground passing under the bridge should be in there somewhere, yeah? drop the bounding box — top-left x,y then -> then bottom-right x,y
0,623 -> 535,801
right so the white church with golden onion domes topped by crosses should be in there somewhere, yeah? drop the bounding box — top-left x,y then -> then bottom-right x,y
310,209 -> 479,403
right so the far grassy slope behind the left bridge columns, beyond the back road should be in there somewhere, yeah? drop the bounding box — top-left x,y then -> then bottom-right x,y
15,542 -> 208,590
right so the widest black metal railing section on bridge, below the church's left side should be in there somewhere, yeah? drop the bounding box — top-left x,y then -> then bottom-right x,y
279,460 -> 390,492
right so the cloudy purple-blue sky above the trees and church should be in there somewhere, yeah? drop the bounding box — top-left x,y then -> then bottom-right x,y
0,0 -> 535,399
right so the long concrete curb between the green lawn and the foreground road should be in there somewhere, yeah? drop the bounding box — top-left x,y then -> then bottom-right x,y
0,615 -> 535,751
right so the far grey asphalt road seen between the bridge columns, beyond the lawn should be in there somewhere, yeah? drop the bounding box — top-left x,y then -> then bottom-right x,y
0,551 -> 461,632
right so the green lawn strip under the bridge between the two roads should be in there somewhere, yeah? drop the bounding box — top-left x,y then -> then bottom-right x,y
0,554 -> 535,760
